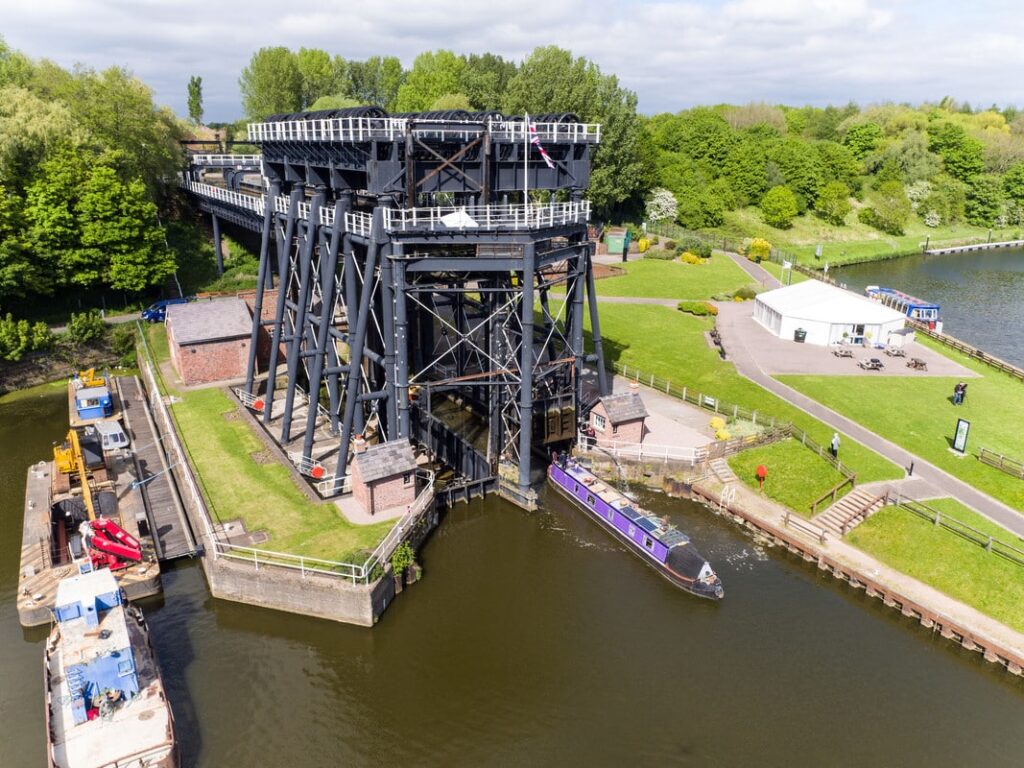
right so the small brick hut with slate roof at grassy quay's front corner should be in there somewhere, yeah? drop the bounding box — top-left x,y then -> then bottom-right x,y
351,440 -> 416,515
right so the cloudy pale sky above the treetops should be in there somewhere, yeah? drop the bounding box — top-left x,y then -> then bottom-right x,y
0,0 -> 1024,121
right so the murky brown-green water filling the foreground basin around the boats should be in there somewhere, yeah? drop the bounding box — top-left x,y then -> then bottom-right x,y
0,395 -> 1024,768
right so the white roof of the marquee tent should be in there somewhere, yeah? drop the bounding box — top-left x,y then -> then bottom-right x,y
757,280 -> 906,325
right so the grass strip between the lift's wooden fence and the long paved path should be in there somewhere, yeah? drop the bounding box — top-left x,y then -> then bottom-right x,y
577,304 -> 903,483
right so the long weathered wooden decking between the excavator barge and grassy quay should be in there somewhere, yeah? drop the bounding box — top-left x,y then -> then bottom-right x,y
115,377 -> 198,560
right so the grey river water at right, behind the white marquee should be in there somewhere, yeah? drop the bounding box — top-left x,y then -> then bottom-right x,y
831,249 -> 1024,368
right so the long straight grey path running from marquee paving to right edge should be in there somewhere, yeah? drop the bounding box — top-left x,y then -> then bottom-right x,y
712,303 -> 1024,537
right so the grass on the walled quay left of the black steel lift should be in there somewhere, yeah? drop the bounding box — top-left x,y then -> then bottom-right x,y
146,325 -> 394,563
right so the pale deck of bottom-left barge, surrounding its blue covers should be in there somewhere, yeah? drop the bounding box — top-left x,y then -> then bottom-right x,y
47,608 -> 174,768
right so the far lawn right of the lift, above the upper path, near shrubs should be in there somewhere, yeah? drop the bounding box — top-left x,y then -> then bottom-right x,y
595,254 -> 755,299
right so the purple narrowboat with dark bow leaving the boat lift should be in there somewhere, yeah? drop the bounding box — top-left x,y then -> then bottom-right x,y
548,456 -> 725,600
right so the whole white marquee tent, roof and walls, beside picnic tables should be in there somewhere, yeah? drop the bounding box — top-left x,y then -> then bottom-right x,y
754,280 -> 906,345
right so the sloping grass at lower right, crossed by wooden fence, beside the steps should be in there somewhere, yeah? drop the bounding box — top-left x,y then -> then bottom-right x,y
847,499 -> 1024,632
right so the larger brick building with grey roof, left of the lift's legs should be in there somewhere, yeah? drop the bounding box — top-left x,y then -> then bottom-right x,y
167,298 -> 252,384
